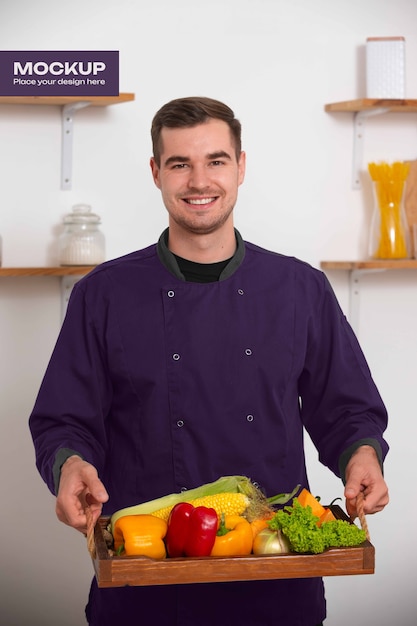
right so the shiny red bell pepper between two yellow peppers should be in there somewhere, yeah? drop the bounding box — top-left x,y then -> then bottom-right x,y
165,502 -> 218,557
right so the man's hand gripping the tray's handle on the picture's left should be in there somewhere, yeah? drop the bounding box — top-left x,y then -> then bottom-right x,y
55,455 -> 109,534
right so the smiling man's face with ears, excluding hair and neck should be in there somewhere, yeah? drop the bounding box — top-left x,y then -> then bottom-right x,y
151,119 -> 245,235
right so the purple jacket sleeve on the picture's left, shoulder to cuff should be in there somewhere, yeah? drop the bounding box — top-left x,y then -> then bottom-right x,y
29,280 -> 112,494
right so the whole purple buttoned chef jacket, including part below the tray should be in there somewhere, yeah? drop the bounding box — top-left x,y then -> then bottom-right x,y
30,231 -> 388,626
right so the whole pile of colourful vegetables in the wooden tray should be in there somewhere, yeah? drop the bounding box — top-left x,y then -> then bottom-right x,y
109,476 -> 366,559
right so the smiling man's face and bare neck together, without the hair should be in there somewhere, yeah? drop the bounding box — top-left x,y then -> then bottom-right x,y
151,119 -> 245,251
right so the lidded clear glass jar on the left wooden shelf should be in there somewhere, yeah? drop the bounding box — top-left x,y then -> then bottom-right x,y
59,204 -> 105,265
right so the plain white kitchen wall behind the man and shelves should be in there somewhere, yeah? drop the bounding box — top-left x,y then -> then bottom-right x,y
0,0 -> 417,626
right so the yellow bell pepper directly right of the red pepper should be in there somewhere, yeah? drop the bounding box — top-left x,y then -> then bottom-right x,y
210,515 -> 253,556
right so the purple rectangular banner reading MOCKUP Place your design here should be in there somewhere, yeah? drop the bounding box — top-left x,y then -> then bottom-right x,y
0,50 -> 119,96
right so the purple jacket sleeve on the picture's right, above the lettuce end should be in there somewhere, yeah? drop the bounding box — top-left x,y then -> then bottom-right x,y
299,273 -> 388,480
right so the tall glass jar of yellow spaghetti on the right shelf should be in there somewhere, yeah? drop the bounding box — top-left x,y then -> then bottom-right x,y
368,162 -> 410,259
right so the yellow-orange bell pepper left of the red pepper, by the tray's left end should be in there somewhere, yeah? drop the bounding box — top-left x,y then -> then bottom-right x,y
113,515 -> 168,559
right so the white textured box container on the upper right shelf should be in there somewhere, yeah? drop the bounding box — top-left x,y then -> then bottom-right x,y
366,37 -> 405,100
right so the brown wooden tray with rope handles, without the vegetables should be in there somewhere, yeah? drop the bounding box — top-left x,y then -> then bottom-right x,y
88,506 -> 375,587
